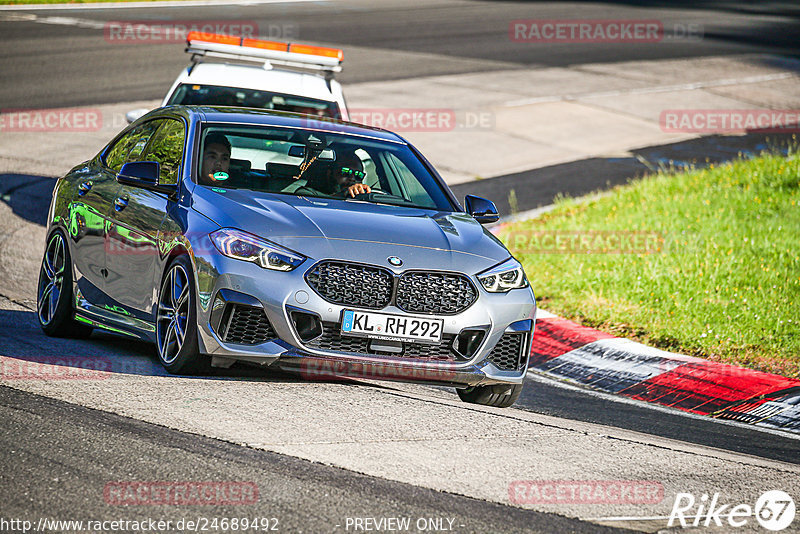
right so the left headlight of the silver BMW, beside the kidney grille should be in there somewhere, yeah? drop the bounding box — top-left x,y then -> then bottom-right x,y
208,228 -> 305,271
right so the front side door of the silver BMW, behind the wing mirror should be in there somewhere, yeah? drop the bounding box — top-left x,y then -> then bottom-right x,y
106,118 -> 186,322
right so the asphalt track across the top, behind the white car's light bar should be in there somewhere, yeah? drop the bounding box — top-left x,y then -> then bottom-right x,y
0,0 -> 800,109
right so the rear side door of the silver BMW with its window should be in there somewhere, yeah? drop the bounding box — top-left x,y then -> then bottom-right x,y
67,119 -> 160,308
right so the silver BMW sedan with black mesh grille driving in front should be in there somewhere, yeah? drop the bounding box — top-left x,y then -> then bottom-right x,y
38,106 -> 536,407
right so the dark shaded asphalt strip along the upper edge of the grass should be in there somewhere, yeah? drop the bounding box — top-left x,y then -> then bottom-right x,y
451,133 -> 797,217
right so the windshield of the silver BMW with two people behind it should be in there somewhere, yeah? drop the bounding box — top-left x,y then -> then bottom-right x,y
195,125 -> 454,211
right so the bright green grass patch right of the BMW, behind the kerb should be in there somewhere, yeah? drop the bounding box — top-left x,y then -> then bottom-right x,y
499,149 -> 800,378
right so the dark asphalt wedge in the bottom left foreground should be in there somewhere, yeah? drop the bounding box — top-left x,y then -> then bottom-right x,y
0,386 -> 615,532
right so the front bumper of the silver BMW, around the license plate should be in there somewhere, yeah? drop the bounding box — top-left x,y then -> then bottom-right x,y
191,255 -> 536,387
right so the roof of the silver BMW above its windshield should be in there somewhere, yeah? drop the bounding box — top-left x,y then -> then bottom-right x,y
176,106 -> 407,144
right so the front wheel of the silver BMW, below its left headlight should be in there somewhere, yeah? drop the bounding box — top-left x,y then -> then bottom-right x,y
156,256 -> 208,374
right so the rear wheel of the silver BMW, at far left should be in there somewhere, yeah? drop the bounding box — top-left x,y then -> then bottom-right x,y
36,230 -> 92,339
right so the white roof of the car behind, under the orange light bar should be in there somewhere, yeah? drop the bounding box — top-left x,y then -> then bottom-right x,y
177,63 -> 336,102
